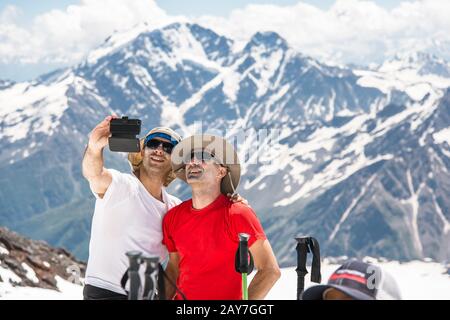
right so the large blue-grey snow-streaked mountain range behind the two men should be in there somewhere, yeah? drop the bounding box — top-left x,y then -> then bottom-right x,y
0,24 -> 450,265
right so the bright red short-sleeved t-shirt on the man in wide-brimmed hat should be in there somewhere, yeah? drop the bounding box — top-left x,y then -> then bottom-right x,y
163,195 -> 266,300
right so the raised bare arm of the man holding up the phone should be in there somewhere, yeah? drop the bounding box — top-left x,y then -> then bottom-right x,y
82,116 -> 116,197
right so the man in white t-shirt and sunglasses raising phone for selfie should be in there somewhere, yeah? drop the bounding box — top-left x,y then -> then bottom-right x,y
82,116 -> 181,299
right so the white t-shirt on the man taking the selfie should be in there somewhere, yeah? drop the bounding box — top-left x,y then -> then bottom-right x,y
85,169 -> 181,294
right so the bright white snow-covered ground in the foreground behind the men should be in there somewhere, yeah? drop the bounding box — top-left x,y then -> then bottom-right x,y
0,260 -> 450,300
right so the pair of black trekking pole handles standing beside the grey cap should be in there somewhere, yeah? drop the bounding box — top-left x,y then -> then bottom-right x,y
295,237 -> 322,300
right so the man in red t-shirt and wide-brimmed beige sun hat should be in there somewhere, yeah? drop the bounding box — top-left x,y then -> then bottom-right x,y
163,135 -> 280,300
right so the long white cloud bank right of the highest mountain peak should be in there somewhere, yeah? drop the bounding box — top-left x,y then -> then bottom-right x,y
198,0 -> 450,63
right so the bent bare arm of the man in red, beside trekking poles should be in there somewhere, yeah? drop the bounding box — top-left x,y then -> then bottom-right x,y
248,240 -> 281,300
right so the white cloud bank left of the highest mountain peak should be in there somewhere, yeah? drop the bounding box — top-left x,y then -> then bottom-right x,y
0,0 -> 173,63
